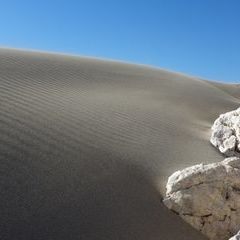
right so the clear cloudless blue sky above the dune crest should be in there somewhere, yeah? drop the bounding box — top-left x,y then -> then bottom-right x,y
0,0 -> 240,83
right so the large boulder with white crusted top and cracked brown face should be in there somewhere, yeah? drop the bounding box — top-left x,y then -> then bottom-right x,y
163,157 -> 240,240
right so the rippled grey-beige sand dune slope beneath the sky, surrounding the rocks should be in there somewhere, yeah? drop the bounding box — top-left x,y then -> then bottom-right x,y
0,49 -> 240,240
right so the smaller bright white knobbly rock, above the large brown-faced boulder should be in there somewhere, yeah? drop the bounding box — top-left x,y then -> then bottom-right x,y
210,108 -> 240,157
